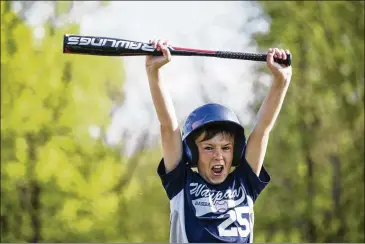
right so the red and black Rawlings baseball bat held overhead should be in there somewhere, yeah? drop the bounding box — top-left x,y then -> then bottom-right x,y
63,34 -> 291,66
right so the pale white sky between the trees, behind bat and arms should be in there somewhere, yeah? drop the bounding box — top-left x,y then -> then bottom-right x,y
17,1 -> 269,154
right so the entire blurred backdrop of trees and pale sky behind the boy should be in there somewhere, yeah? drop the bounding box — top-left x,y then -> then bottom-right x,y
1,1 -> 364,243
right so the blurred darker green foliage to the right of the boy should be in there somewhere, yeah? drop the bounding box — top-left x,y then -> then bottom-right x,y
250,1 -> 364,242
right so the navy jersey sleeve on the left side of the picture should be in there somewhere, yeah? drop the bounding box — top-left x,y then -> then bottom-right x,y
157,158 -> 187,200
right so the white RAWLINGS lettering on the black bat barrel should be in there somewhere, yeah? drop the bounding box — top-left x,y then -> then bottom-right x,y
67,36 -> 172,52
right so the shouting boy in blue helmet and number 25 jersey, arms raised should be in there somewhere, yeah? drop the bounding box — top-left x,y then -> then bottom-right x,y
146,39 -> 292,243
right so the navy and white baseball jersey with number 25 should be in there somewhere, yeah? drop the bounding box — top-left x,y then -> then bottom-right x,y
157,156 -> 270,243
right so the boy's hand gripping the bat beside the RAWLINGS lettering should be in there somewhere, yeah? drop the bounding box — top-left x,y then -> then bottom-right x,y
146,39 -> 171,72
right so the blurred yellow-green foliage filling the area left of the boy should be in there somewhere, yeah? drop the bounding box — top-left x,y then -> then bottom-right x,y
1,2 -> 169,242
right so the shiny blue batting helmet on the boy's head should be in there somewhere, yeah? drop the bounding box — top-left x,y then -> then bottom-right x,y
182,103 -> 246,167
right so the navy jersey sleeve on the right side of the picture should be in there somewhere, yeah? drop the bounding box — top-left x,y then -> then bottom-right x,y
237,157 -> 271,202
